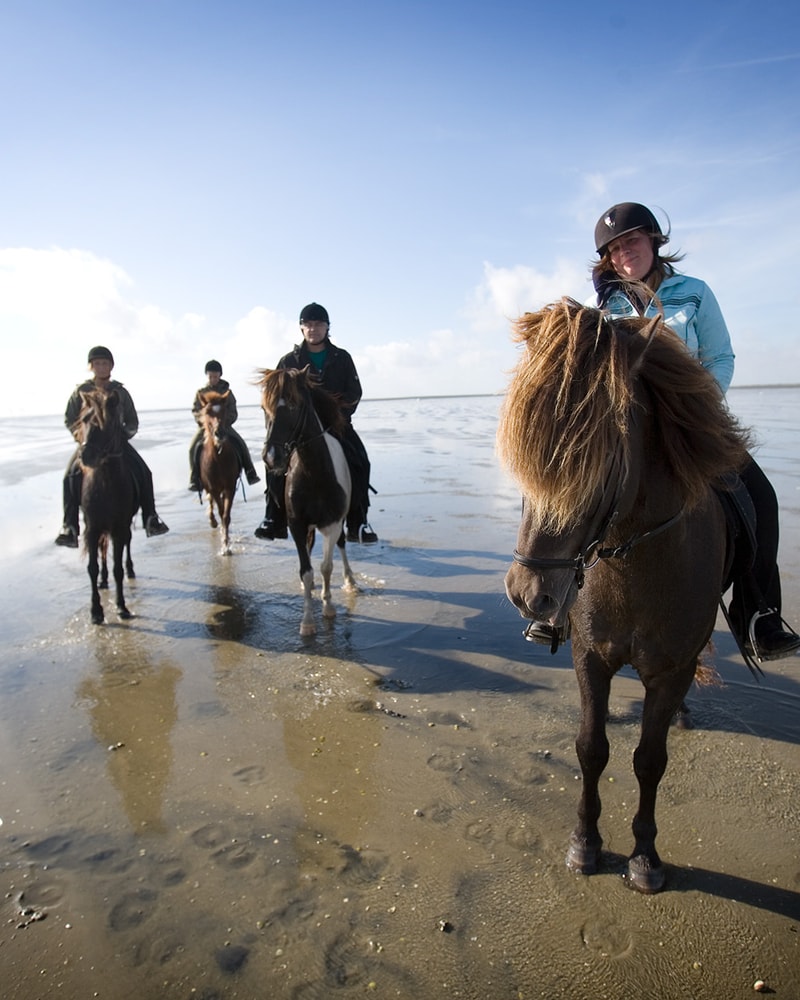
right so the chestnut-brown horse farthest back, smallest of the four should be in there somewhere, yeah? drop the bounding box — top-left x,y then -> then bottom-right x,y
200,391 -> 242,555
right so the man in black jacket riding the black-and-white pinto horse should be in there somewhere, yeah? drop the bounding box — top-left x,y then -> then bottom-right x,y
255,302 -> 378,543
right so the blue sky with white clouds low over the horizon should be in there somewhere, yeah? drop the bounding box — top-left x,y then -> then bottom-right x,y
0,0 -> 800,417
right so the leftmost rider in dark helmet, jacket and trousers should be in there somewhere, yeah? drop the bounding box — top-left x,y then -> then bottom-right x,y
56,347 -> 169,549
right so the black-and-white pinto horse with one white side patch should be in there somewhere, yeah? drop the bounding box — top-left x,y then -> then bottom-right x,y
259,368 -> 358,635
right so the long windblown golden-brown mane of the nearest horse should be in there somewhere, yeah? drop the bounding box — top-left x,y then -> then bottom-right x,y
497,298 -> 750,530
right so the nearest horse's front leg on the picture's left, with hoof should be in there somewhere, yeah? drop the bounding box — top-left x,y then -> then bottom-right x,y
567,645 -> 612,875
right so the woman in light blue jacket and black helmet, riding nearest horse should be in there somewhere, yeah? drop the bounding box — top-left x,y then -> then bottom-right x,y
532,202 -> 800,660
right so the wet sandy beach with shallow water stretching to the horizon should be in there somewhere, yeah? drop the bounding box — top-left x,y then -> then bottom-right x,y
0,389 -> 800,1000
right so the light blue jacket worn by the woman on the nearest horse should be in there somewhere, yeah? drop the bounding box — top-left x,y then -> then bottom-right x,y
593,274 -> 735,392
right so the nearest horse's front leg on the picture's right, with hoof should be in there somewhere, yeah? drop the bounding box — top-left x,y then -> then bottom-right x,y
628,664 -> 695,893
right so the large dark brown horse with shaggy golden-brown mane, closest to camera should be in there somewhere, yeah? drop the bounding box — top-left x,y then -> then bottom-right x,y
497,299 -> 749,893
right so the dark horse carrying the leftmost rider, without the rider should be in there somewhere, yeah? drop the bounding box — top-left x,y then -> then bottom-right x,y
73,390 -> 139,625
